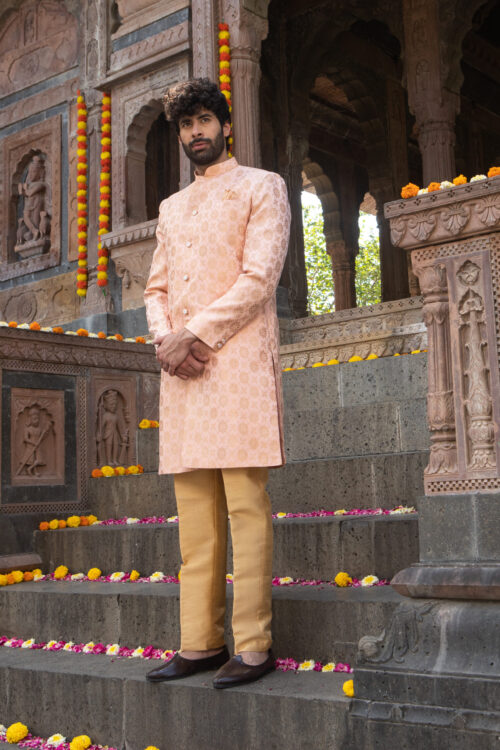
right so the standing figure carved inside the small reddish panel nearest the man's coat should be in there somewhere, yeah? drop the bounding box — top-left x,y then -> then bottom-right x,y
97,388 -> 130,466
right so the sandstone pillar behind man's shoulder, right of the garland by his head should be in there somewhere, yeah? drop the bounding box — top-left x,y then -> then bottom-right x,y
222,0 -> 268,167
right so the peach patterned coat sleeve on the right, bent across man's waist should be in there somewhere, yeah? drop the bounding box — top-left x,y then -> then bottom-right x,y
186,172 -> 290,350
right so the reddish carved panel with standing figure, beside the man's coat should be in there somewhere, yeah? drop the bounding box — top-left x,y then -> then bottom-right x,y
89,373 -> 137,468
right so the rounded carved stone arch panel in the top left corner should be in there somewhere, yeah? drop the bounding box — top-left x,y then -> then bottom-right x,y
0,0 -> 78,97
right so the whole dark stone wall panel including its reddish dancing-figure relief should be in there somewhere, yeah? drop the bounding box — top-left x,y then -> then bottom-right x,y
0,370 -> 78,512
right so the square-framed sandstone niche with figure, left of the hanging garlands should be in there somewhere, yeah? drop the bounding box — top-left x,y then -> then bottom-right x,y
0,116 -> 61,280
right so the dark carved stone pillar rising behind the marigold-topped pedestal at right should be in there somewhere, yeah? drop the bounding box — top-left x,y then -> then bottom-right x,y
403,0 -> 460,185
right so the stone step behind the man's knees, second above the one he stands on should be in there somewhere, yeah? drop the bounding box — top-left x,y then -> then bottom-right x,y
35,514 -> 418,580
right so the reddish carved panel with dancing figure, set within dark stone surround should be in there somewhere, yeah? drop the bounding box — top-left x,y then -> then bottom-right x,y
11,388 -> 65,486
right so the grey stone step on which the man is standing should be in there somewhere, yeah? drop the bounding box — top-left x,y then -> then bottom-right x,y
0,648 -> 349,750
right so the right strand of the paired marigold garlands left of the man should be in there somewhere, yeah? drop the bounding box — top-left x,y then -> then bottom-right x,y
97,94 -> 111,291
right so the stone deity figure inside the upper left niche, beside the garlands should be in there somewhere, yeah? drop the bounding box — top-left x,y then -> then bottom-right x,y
14,156 -> 50,258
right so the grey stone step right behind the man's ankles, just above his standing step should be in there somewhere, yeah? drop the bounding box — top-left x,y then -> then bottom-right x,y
0,581 -> 403,663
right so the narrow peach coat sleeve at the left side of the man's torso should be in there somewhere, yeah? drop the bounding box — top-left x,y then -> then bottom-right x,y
144,208 -> 172,336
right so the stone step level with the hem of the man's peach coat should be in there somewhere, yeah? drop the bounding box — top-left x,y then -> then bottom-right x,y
88,451 -> 429,519
